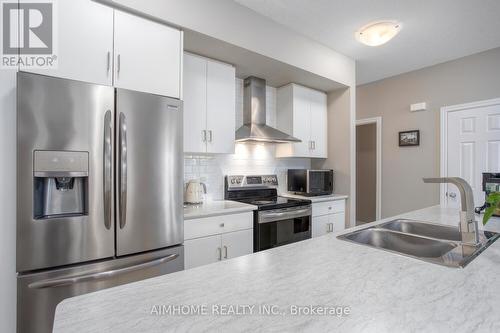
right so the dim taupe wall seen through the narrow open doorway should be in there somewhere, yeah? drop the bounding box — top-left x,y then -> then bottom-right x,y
356,124 -> 377,222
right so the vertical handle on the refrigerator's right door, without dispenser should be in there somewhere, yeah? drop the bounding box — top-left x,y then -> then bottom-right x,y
118,113 -> 127,229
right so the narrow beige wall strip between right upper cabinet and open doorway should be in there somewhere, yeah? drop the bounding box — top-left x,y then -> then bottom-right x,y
311,88 -> 354,225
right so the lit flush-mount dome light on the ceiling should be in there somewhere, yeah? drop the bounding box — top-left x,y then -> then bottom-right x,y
355,21 -> 401,46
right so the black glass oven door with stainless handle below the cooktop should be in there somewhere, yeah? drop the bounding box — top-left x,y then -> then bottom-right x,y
254,205 -> 312,252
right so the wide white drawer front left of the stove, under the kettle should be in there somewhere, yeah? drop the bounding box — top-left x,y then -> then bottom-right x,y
184,212 -> 253,240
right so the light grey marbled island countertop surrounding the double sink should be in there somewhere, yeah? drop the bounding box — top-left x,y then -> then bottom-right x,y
54,206 -> 500,333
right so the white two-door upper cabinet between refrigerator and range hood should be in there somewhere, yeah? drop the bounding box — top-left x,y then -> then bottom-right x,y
183,53 -> 236,154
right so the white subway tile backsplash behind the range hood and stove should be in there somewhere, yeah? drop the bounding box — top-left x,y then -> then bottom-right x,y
184,79 -> 311,200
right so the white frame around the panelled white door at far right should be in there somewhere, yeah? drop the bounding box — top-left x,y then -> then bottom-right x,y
439,98 -> 500,207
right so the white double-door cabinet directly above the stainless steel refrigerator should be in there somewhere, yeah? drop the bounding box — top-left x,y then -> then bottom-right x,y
19,0 -> 182,98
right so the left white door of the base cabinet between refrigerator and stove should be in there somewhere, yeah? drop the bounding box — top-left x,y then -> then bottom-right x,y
184,235 -> 222,269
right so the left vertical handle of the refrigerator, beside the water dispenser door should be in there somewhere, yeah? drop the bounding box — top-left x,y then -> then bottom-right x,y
103,110 -> 113,230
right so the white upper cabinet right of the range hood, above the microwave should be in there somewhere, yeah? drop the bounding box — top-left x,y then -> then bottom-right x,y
276,84 -> 328,158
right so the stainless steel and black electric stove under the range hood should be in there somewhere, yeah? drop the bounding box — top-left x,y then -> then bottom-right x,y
224,175 -> 312,252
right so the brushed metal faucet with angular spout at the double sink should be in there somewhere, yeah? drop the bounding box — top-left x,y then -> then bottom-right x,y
423,177 -> 479,245
